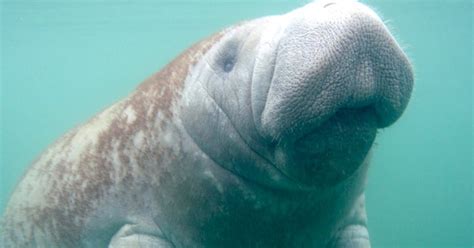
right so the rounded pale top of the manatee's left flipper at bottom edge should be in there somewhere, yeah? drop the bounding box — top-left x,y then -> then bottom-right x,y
109,224 -> 174,248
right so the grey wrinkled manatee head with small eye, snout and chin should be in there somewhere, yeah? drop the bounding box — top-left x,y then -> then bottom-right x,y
181,1 -> 413,189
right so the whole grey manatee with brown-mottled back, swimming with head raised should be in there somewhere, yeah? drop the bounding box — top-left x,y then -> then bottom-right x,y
1,1 -> 413,247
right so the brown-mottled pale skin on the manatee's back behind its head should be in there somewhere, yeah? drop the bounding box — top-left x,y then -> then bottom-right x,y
2,30 -> 221,247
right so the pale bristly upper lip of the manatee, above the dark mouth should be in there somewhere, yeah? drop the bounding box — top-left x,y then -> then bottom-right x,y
252,3 -> 413,145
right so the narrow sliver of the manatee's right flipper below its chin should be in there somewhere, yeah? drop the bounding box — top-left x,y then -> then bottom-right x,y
328,194 -> 370,248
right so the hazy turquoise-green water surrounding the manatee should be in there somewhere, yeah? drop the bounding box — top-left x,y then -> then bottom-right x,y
0,0 -> 474,247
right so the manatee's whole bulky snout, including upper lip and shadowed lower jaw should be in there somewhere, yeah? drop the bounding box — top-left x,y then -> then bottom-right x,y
254,1 -> 413,185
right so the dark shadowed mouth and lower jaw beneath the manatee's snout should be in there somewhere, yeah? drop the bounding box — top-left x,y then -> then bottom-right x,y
275,107 -> 378,187
